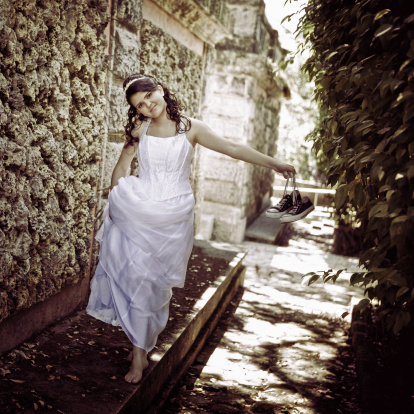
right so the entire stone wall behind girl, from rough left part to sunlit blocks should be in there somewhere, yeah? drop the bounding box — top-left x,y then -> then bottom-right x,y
0,0 -> 280,353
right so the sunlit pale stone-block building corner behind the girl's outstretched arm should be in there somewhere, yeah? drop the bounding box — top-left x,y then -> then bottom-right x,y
198,0 -> 284,242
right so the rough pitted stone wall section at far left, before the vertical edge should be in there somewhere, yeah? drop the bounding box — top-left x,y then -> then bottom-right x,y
0,0 -> 108,320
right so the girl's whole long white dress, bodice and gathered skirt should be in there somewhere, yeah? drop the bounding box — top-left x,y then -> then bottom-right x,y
86,120 -> 194,352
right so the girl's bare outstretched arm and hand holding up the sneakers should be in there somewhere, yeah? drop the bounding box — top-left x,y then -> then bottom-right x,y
189,119 -> 296,178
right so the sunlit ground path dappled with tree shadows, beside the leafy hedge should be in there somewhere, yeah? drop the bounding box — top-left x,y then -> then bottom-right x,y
165,210 -> 361,414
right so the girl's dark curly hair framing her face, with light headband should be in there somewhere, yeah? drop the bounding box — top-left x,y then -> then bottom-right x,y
123,73 -> 191,148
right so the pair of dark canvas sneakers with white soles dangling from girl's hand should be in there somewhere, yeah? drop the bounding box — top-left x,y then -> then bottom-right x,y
266,189 -> 315,223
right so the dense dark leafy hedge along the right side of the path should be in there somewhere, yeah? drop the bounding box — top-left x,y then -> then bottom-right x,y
299,0 -> 414,333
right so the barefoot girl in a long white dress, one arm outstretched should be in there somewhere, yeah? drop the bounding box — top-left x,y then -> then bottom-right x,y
87,74 -> 295,384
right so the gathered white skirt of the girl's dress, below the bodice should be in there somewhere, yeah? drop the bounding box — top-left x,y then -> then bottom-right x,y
86,176 -> 194,352
